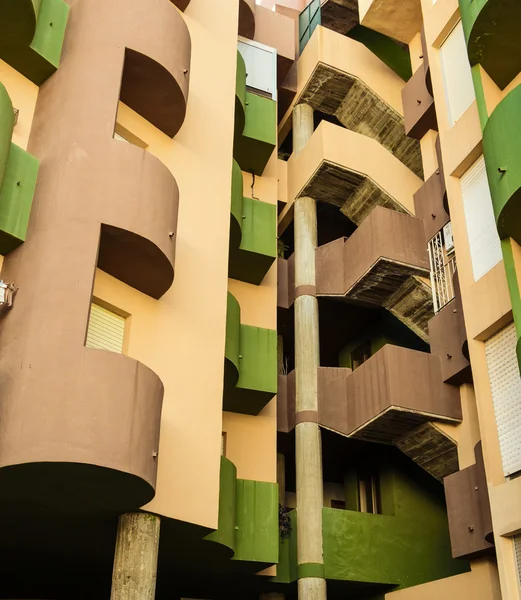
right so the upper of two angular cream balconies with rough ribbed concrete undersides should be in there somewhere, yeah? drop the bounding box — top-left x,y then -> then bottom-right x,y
297,26 -> 423,177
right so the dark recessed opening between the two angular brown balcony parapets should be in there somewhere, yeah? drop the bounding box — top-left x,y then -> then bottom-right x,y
319,298 -> 429,370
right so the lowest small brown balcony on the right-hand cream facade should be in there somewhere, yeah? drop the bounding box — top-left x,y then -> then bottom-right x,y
444,442 -> 494,560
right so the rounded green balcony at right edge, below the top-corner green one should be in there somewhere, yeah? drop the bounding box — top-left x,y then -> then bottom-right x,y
483,86 -> 521,243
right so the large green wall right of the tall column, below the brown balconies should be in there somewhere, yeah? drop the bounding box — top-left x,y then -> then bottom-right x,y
323,469 -> 468,587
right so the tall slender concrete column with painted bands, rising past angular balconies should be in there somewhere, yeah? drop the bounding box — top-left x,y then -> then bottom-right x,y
293,104 -> 326,600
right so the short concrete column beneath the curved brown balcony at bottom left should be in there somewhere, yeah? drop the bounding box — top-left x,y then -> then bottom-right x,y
110,513 -> 160,600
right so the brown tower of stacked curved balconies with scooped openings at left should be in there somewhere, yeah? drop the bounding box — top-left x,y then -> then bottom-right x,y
0,0 -> 190,512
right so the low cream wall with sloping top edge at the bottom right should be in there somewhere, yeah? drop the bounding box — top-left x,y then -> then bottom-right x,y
385,556 -> 500,600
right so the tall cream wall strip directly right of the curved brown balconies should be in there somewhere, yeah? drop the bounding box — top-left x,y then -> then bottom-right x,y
94,0 -> 238,527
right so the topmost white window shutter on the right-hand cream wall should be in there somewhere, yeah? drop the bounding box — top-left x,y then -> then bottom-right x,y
440,21 -> 476,126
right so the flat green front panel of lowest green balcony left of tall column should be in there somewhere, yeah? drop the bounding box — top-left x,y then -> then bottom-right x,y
234,479 -> 279,564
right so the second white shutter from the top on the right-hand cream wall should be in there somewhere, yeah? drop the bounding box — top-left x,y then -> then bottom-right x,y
461,156 -> 503,281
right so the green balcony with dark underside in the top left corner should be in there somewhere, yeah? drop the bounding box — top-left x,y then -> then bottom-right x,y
0,0 -> 69,85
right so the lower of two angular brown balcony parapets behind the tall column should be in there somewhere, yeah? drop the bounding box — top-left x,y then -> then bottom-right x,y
278,344 -> 461,444
